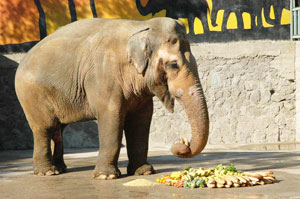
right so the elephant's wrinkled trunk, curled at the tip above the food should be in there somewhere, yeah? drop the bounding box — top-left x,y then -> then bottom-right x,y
171,81 -> 209,158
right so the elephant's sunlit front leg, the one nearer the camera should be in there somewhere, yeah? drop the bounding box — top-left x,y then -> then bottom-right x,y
93,111 -> 123,180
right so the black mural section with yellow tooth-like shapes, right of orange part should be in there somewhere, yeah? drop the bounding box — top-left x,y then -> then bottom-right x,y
136,0 -> 290,42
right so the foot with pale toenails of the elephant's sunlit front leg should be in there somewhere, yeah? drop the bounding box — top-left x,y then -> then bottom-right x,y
93,166 -> 121,180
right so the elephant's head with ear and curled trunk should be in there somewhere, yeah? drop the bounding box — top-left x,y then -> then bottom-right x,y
128,18 -> 209,158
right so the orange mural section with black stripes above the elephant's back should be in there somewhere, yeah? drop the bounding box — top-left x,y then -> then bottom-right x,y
0,0 -> 165,52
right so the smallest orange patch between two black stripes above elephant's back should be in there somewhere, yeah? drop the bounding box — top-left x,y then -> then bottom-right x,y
73,0 -> 93,20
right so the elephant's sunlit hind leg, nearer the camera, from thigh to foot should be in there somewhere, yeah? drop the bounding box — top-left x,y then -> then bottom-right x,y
16,81 -> 59,176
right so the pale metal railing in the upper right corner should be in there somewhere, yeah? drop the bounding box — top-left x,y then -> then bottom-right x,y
290,0 -> 300,40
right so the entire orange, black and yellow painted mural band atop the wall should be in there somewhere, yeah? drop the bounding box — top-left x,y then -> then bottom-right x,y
0,0 -> 290,52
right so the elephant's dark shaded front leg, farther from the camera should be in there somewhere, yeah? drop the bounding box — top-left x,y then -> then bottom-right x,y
125,99 -> 155,175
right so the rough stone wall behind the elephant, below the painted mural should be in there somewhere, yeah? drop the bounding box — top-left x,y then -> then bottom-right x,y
0,41 -> 300,149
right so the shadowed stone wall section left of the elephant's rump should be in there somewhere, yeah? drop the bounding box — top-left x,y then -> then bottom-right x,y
0,54 -> 33,150
